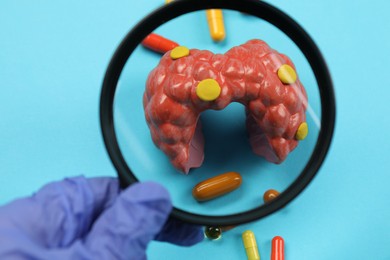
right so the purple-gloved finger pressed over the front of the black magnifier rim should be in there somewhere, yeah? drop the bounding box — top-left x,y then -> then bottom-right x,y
80,182 -> 172,259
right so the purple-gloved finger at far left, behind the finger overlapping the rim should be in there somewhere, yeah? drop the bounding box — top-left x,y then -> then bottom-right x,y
0,177 -> 119,249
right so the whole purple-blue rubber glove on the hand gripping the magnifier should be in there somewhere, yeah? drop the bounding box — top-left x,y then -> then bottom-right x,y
0,177 -> 203,260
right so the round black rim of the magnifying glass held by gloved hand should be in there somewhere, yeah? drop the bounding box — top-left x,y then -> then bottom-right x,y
100,0 -> 336,226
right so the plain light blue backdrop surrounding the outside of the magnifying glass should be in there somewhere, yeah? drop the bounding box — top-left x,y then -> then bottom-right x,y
0,0 -> 390,260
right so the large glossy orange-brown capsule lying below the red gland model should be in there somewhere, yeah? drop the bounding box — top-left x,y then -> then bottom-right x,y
192,172 -> 242,201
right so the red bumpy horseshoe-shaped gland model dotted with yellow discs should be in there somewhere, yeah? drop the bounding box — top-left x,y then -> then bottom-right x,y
143,40 -> 308,173
